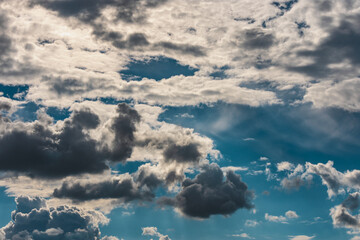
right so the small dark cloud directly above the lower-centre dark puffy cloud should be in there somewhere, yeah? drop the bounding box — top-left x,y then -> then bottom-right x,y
164,143 -> 201,163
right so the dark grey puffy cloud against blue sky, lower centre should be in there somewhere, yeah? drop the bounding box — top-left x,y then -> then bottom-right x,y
159,163 -> 254,218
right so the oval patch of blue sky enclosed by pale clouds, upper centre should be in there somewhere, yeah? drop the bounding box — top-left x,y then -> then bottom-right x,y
119,56 -> 198,81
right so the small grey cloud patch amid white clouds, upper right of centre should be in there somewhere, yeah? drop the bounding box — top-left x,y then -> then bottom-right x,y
242,29 -> 275,49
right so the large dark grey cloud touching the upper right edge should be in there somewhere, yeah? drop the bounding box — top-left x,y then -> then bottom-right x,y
288,15 -> 360,77
